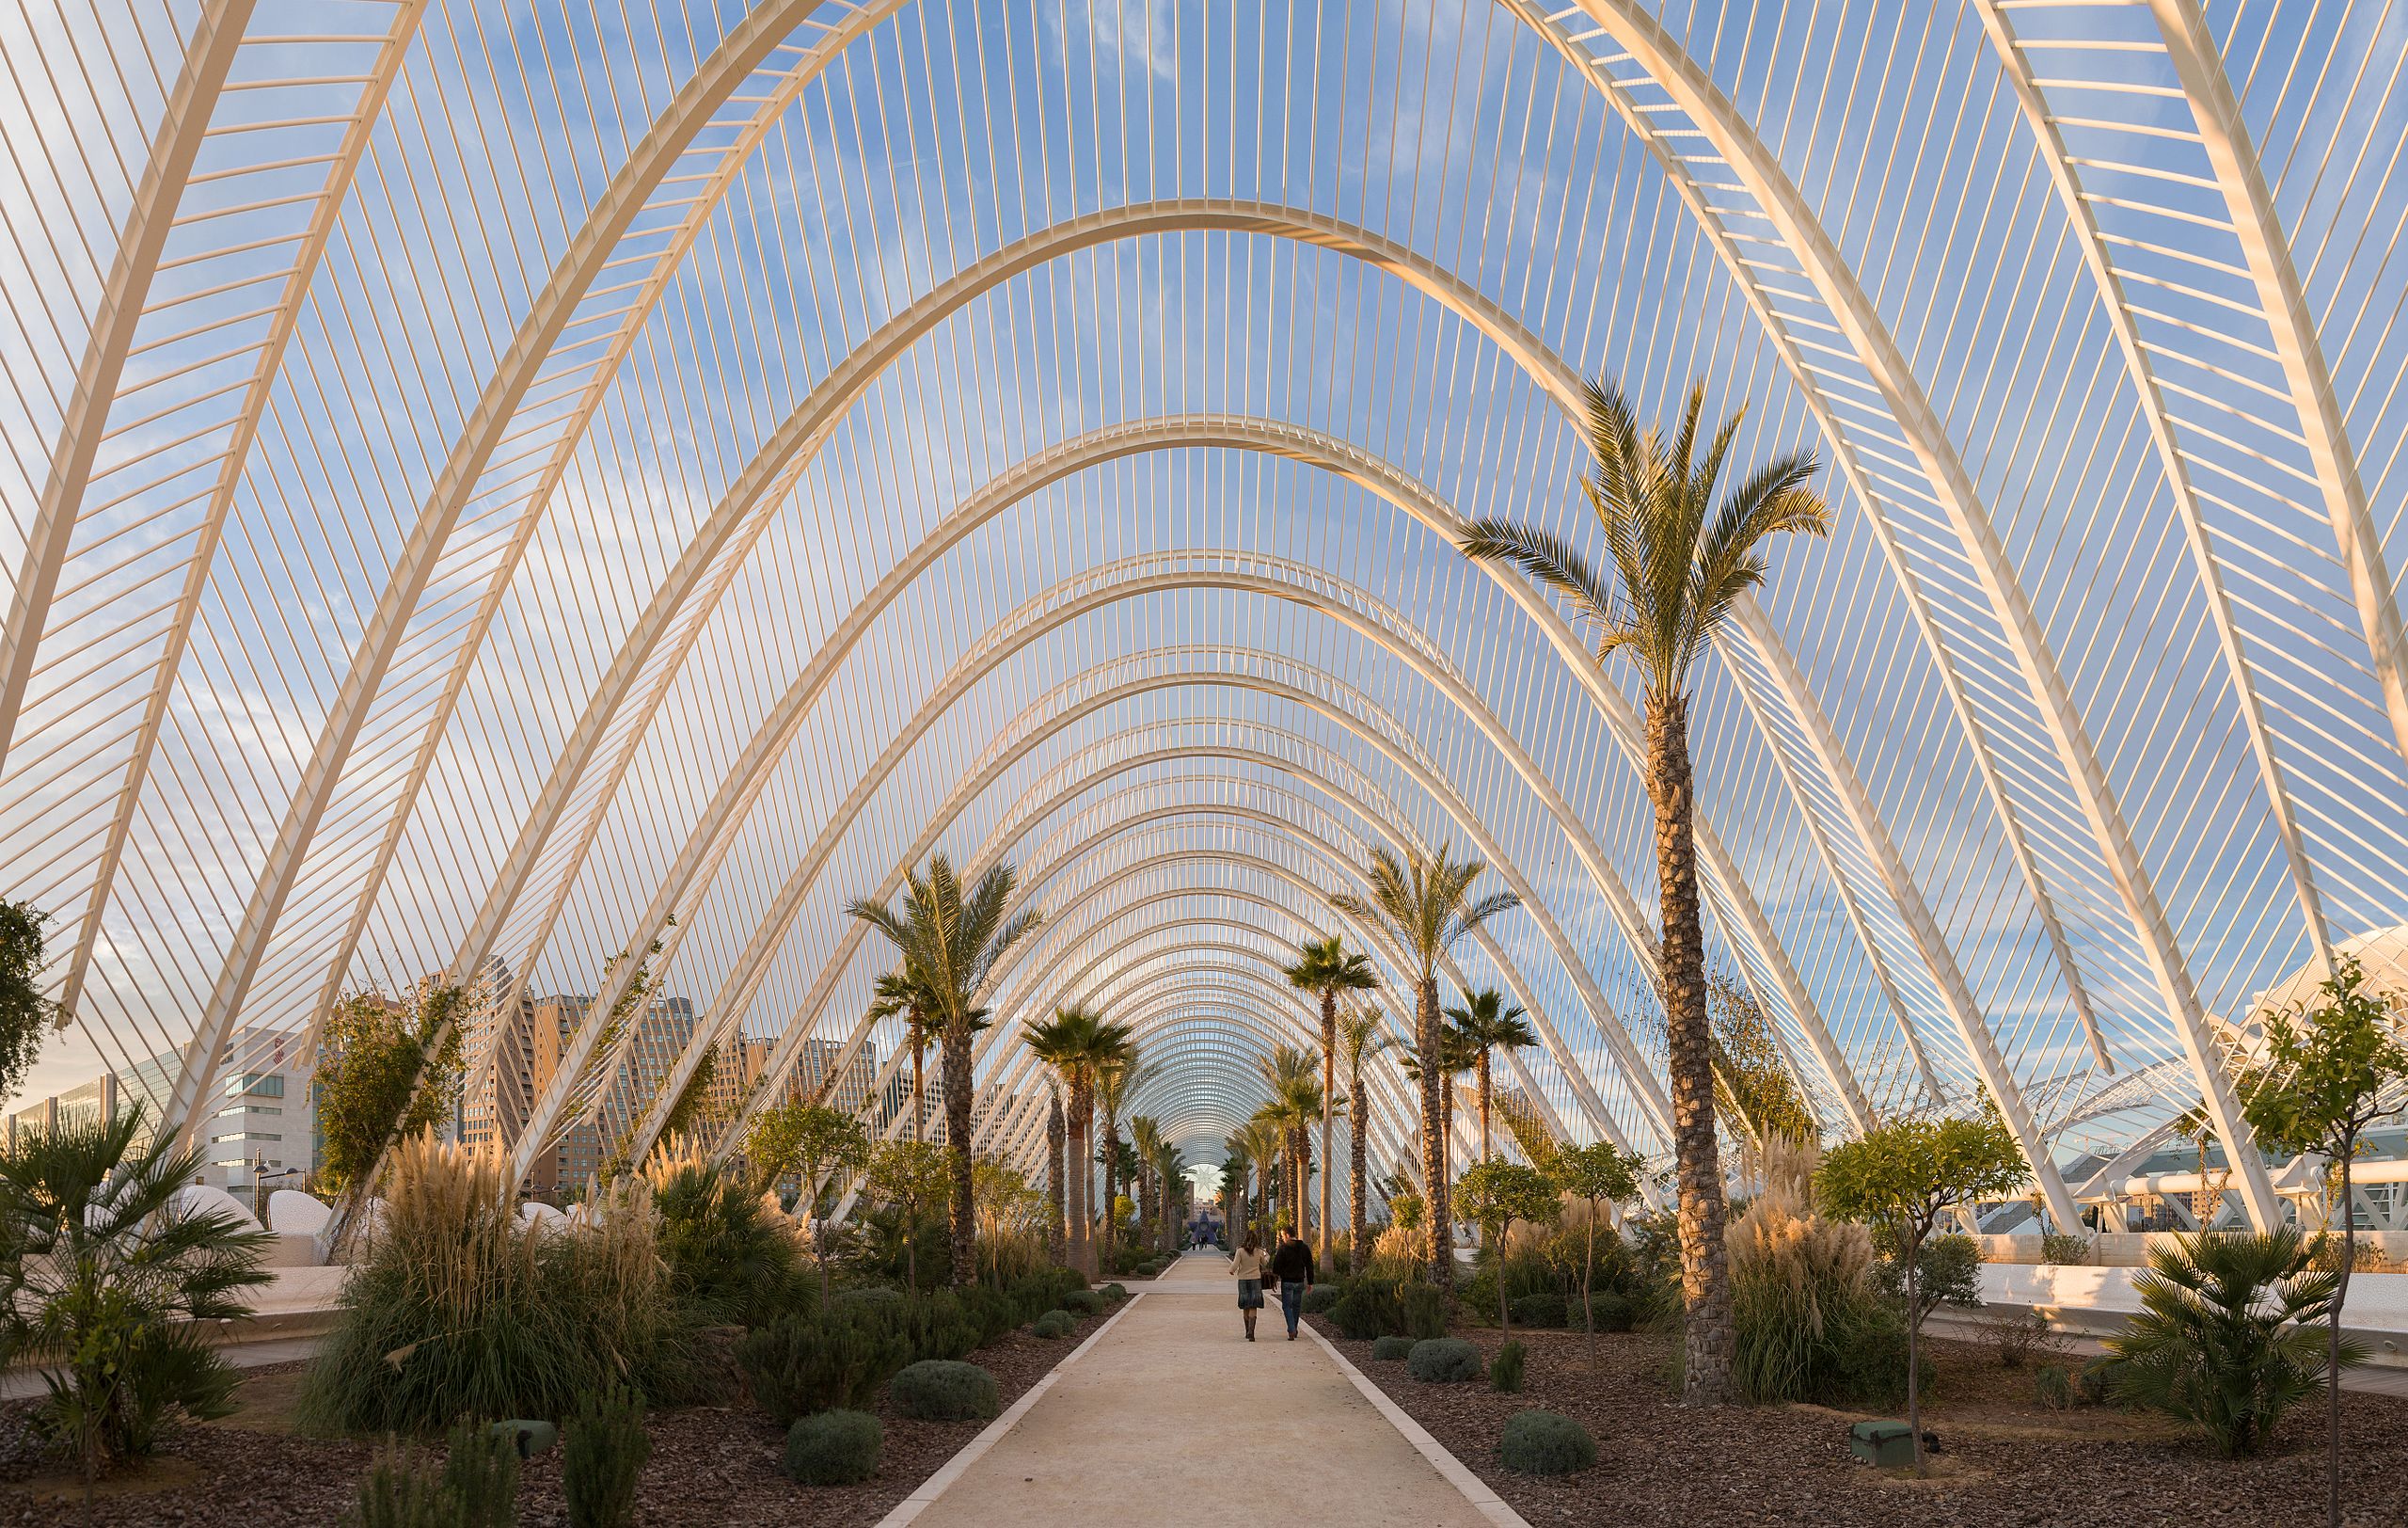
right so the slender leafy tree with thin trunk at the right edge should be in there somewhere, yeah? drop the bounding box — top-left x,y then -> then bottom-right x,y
2242,954 -> 2408,1528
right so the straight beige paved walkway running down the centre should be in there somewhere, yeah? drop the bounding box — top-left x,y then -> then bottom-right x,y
889,1253 -> 1519,1528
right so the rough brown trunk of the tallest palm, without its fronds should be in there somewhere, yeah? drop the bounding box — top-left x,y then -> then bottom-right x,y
1647,690 -> 1734,1405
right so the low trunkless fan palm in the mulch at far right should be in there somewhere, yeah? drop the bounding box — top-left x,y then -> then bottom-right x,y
2107,1227 -> 2365,1458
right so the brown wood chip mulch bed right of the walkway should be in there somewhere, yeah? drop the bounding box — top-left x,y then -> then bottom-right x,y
1312,1316 -> 2408,1528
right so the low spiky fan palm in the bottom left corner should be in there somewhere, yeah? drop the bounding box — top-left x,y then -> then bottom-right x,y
0,1108 -> 270,1480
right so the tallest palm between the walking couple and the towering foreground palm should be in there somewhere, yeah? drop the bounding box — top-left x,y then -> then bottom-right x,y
1329,844 -> 1522,1289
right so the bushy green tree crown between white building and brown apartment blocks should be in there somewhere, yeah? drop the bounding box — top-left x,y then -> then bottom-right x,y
313,983 -> 463,1188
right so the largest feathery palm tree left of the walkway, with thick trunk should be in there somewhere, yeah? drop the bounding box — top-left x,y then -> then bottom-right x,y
846,853 -> 1042,1284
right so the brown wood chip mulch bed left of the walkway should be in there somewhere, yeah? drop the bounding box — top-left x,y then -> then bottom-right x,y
0,1306 -> 1117,1528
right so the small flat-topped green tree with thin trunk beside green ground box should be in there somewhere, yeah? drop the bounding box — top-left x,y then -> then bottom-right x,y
1815,1108 -> 2025,1475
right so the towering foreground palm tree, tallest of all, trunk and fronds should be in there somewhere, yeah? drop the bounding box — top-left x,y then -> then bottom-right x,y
1462,381 -> 1830,1405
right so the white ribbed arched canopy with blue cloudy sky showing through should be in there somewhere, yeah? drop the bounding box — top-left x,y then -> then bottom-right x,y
0,0 -> 2408,1218
